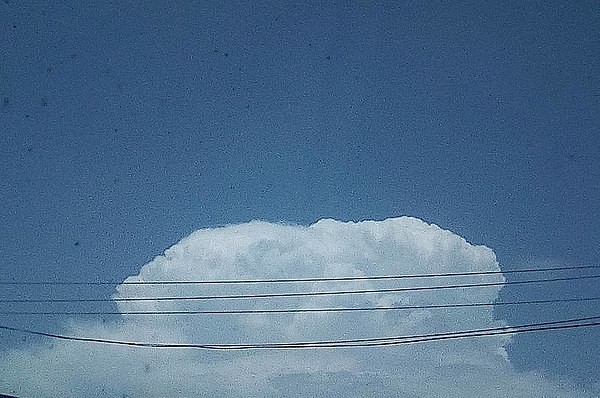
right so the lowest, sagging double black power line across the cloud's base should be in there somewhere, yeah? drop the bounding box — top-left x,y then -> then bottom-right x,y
0,316 -> 600,350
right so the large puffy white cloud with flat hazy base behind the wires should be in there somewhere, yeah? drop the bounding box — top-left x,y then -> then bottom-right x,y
0,217 -> 592,398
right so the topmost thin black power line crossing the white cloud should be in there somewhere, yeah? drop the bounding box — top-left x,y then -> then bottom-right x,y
0,265 -> 600,286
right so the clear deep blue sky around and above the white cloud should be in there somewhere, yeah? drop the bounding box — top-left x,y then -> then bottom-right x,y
0,0 -> 600,394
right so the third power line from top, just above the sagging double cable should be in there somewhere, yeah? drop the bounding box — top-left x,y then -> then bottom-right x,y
0,297 -> 600,315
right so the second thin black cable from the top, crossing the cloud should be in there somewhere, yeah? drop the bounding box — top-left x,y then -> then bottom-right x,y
0,275 -> 600,303
